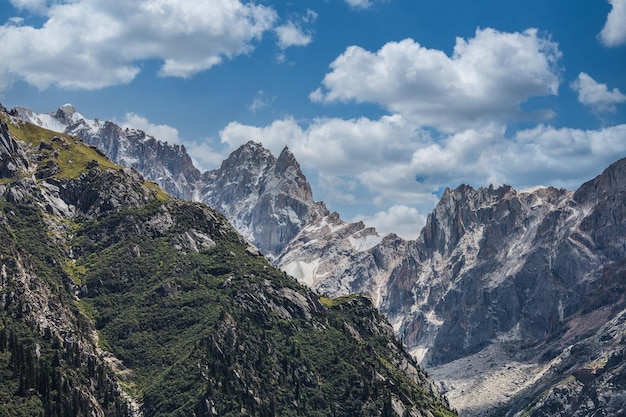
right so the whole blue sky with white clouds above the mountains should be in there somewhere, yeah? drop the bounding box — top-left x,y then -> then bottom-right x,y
0,0 -> 626,238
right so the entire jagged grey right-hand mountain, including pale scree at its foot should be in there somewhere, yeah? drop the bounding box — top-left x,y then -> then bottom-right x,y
381,160 -> 626,415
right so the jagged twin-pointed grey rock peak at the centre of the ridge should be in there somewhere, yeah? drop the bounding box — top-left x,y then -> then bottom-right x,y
199,142 -> 328,258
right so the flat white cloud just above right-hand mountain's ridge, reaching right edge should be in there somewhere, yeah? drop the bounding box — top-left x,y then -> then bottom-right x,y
412,125 -> 626,189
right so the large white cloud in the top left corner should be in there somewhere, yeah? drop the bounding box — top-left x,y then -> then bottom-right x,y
0,0 -> 277,89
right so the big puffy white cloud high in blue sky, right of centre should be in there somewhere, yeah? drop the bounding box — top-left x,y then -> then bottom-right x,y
310,29 -> 561,132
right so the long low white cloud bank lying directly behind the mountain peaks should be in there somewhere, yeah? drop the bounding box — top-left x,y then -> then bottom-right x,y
220,115 -> 626,232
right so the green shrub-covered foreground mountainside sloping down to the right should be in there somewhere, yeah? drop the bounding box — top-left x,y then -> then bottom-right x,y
0,108 -> 454,417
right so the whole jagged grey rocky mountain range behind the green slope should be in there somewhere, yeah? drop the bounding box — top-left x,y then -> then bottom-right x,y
11,102 -> 626,416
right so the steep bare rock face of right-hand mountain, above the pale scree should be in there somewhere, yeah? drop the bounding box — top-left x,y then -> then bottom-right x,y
381,160 -> 626,365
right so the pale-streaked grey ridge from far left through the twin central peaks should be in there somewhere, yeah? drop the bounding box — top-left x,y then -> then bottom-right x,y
11,104 -> 393,282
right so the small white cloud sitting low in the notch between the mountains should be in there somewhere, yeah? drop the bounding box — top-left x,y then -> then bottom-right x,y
352,206 -> 426,240
